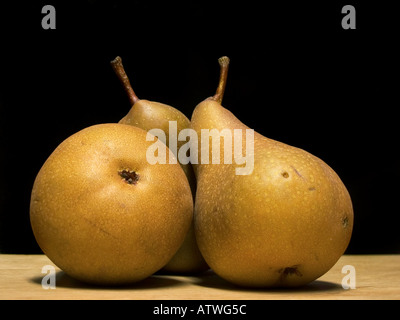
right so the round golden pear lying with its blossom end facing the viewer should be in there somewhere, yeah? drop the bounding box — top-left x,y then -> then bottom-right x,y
30,124 -> 193,285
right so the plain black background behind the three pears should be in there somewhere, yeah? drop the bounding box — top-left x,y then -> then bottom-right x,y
0,0 -> 400,253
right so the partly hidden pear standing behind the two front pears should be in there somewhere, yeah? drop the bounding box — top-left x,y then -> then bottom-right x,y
111,56 -> 209,273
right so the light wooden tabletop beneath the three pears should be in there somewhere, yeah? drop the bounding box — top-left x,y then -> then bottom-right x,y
0,254 -> 400,300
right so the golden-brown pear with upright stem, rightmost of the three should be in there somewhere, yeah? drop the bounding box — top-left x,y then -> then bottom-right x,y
191,57 -> 353,287
